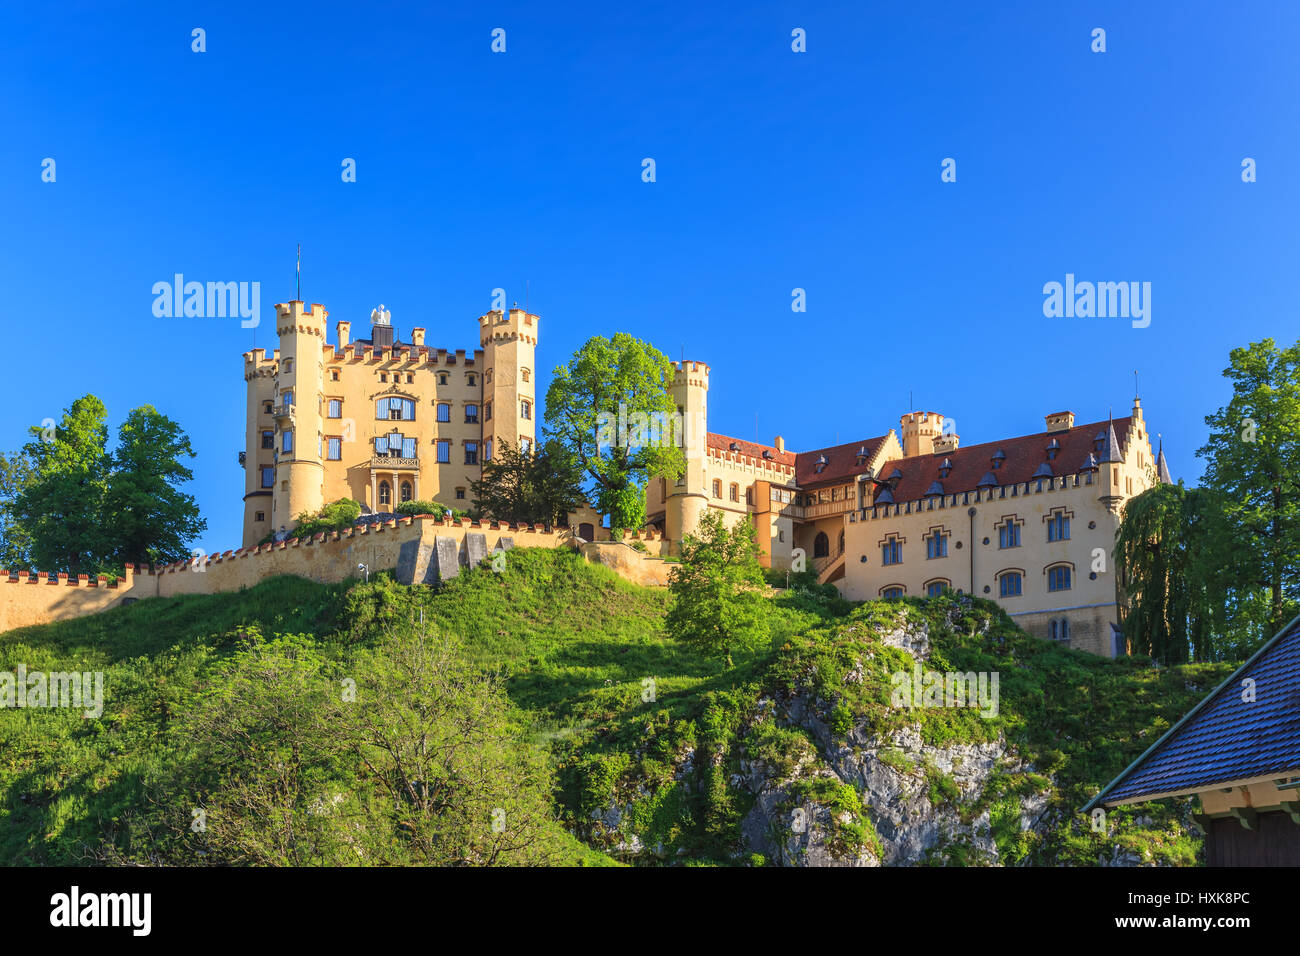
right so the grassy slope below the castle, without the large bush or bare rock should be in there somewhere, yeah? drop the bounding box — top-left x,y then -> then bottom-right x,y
0,549 -> 1231,865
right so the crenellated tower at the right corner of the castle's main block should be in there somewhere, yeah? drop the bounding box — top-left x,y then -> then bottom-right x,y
478,308 -> 541,455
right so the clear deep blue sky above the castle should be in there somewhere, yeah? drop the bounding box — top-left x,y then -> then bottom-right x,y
0,1 -> 1300,551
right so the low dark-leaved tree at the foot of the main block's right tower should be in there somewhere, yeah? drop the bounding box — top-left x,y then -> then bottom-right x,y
469,441 -> 582,524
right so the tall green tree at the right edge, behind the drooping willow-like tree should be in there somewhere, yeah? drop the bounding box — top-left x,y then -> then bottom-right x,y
1197,338 -> 1300,632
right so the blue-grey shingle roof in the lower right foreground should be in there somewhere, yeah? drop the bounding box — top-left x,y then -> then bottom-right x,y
1084,618 -> 1300,810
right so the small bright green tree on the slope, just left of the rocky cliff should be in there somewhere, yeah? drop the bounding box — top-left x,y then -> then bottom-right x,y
664,511 -> 767,666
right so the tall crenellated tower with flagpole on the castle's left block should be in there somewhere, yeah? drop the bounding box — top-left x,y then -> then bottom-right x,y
270,299 -> 329,529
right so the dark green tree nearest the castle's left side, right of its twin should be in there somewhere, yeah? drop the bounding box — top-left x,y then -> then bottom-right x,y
101,405 -> 208,567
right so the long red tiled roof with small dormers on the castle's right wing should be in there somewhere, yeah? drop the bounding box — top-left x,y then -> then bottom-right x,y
878,418 -> 1132,502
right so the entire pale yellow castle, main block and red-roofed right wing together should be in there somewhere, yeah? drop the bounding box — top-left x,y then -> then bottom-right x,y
243,302 -> 1170,657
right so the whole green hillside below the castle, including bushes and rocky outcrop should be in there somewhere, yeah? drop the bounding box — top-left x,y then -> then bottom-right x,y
0,550 -> 1230,865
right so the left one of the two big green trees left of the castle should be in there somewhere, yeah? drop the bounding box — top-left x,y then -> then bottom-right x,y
12,395 -> 111,574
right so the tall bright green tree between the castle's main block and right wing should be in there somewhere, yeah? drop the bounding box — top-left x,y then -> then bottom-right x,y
546,332 -> 685,529
